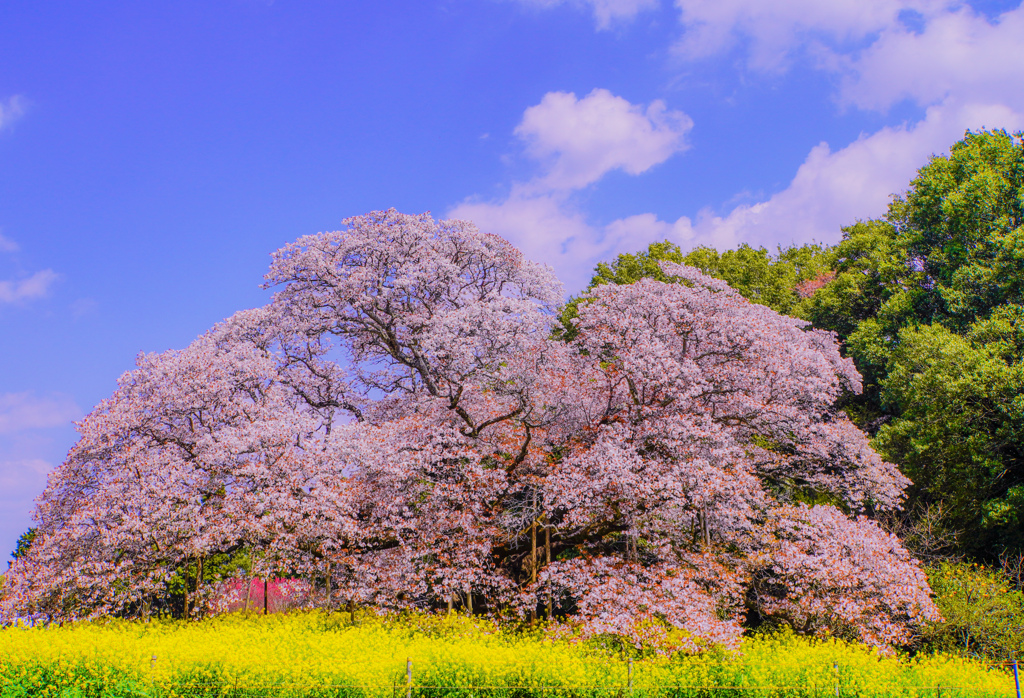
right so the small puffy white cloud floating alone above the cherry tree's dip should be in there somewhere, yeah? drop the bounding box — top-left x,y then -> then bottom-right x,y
515,89 -> 693,189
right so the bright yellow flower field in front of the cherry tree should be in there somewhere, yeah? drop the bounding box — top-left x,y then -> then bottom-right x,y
0,613 -> 1015,698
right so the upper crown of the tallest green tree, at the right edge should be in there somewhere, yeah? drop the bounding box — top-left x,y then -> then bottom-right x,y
803,131 -> 1024,384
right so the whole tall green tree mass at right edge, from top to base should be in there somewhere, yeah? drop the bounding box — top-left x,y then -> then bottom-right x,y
802,131 -> 1024,559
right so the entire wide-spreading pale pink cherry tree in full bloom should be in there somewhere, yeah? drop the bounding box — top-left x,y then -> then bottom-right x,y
2,210 -> 935,651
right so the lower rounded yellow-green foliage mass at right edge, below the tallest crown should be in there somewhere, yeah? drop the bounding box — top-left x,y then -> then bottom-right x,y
876,317 -> 1024,557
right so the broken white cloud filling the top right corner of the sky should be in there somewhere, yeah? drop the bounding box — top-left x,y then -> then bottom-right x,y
674,0 -> 1024,111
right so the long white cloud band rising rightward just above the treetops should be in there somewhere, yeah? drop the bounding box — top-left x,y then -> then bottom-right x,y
468,102 -> 1024,292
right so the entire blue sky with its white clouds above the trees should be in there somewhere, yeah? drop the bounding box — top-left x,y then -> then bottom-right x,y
0,0 -> 1024,555
